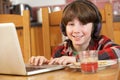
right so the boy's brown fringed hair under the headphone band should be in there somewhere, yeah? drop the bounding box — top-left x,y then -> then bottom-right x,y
62,1 -> 97,25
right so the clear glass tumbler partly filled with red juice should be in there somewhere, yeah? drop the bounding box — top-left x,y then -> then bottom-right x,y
79,50 -> 98,73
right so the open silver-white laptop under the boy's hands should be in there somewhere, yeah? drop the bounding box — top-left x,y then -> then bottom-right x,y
0,23 -> 64,75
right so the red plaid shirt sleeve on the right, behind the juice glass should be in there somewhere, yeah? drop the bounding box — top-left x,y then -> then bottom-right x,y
98,36 -> 120,60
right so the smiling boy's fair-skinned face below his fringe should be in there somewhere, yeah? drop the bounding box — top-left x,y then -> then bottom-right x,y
66,18 -> 93,46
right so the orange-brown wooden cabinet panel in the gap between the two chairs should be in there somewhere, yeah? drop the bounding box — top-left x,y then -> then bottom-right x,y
31,26 -> 44,56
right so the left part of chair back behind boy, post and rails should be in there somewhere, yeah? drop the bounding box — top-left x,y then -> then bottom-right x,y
42,8 -> 62,59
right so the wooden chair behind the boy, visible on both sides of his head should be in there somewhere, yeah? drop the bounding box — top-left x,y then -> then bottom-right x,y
42,4 -> 114,58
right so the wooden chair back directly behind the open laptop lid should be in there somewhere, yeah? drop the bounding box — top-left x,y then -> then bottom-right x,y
0,10 -> 31,62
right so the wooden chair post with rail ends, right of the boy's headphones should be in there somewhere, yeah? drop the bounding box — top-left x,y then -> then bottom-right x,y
100,4 -> 114,40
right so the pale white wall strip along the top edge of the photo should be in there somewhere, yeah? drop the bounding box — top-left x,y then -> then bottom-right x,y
10,0 -> 66,7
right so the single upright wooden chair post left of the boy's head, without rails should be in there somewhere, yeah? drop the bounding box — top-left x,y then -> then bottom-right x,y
42,9 -> 51,59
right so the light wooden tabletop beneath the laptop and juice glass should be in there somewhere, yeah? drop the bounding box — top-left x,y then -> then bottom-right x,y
0,62 -> 119,80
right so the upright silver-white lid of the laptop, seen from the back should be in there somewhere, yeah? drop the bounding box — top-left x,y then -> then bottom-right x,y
0,23 -> 26,75
